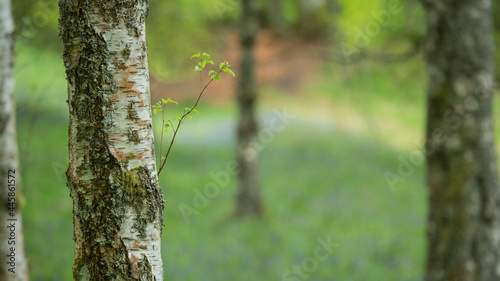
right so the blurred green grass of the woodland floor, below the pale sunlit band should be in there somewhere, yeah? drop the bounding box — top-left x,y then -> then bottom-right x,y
19,108 -> 424,280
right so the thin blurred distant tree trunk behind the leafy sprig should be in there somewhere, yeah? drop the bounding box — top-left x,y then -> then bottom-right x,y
236,0 -> 262,217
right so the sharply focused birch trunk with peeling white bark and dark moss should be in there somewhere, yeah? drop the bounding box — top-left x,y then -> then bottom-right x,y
59,0 -> 163,281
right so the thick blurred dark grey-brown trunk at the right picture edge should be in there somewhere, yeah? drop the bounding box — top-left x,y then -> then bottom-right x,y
423,0 -> 500,281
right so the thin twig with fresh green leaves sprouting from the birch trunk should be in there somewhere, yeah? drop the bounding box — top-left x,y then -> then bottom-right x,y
153,53 -> 235,175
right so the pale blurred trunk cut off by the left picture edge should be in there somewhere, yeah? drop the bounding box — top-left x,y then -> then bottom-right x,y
0,0 -> 29,281
